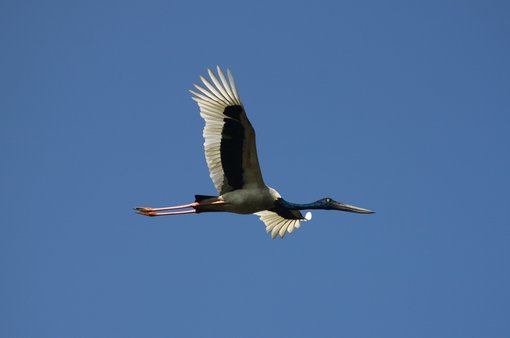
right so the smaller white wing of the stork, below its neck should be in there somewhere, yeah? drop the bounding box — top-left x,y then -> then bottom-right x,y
255,209 -> 312,239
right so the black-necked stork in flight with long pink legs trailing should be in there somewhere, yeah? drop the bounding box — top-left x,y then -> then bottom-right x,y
135,67 -> 373,239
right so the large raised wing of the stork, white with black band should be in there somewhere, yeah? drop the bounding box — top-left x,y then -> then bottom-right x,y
191,67 -> 265,194
